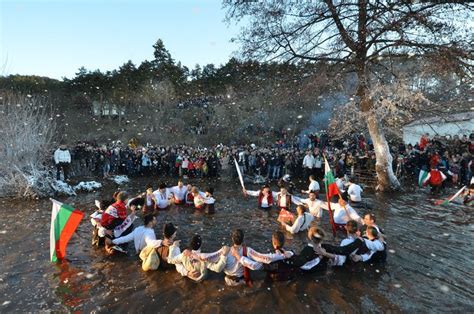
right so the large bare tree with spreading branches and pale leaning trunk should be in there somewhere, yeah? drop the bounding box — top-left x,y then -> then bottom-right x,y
224,0 -> 474,189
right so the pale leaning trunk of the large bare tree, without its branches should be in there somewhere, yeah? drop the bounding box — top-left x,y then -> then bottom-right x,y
367,102 -> 400,191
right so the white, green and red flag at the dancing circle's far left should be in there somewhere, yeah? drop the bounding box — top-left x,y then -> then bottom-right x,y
49,199 -> 84,262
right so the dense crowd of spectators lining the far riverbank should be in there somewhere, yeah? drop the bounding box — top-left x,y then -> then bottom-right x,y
52,133 -> 474,185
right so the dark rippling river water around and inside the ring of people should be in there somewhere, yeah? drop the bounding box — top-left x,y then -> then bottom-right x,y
0,180 -> 474,313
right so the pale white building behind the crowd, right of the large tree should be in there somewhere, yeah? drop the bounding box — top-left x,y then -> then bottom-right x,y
403,111 -> 474,145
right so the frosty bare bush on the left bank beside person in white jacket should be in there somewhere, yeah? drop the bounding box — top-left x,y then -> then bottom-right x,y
0,95 -> 55,197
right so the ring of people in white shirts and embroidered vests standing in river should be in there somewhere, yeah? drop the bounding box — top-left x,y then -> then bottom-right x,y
91,175 -> 386,286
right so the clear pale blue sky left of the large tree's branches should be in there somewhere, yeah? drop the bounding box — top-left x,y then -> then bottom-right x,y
0,0 -> 238,79
